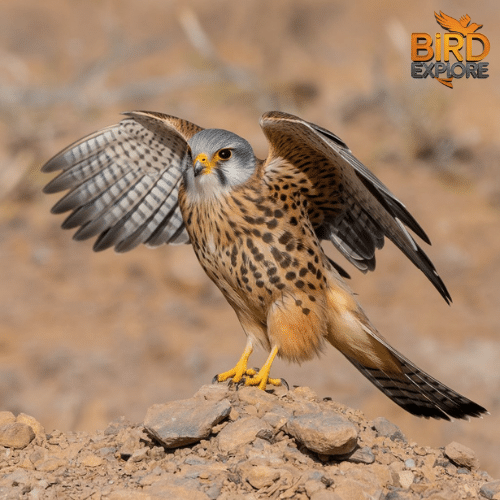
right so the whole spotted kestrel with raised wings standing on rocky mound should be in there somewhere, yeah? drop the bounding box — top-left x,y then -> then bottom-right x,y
42,111 -> 487,420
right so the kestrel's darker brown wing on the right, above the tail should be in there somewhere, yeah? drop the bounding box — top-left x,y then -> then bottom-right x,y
260,111 -> 451,303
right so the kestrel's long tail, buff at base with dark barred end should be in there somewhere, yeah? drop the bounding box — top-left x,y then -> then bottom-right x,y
328,293 -> 488,420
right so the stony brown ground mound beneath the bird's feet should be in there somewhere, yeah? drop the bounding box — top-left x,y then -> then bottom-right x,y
0,385 -> 500,500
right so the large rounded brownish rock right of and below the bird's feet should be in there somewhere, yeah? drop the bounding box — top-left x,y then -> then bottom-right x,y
284,412 -> 358,455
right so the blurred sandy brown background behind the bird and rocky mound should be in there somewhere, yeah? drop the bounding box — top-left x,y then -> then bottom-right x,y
0,0 -> 500,477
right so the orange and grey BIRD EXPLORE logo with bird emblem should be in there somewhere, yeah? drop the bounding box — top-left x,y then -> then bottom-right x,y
411,11 -> 490,89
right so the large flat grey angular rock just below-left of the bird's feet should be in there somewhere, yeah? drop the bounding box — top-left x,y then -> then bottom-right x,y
144,398 -> 231,448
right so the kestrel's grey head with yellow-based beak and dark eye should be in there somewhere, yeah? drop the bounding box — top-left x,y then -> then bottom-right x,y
188,129 -> 257,195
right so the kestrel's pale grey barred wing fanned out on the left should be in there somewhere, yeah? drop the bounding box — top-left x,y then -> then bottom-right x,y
42,111 -> 202,252
